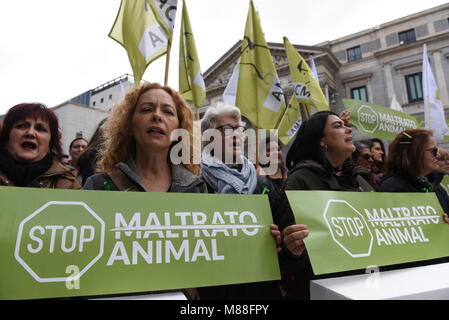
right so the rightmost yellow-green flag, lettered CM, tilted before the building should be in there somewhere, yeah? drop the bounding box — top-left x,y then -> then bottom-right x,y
277,37 -> 329,145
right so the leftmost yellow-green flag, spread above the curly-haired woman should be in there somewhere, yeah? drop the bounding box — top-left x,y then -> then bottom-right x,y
109,0 -> 176,84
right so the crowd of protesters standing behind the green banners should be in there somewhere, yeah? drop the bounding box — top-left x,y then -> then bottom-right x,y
0,82 -> 449,300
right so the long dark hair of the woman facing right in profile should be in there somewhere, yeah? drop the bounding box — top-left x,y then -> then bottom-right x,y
286,111 -> 338,170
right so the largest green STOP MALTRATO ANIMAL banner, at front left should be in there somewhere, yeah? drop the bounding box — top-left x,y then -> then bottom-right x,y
0,187 -> 280,299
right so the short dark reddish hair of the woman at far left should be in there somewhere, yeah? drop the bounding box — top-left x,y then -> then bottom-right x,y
0,102 -> 63,161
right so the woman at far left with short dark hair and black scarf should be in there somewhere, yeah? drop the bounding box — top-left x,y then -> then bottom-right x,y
0,103 -> 81,189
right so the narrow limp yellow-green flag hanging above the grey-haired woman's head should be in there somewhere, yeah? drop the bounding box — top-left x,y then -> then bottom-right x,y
179,1 -> 206,108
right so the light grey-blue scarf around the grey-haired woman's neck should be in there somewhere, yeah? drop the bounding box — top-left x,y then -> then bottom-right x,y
201,154 -> 257,194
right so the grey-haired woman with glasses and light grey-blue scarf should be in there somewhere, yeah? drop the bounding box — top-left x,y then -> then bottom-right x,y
198,104 -> 281,300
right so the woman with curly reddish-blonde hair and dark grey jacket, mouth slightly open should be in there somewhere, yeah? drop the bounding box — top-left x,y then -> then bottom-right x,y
84,82 -> 207,193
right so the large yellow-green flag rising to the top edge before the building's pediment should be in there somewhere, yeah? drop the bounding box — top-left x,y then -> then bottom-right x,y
236,1 -> 285,129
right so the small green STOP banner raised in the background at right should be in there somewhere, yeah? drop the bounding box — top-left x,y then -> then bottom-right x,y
343,99 -> 418,141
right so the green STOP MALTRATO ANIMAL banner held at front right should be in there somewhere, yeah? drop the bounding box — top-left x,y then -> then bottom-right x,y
287,191 -> 449,274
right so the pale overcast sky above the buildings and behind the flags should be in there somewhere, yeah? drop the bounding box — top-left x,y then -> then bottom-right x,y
0,0 -> 446,114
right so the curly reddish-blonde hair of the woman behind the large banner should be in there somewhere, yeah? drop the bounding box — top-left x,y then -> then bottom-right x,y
99,82 -> 199,175
